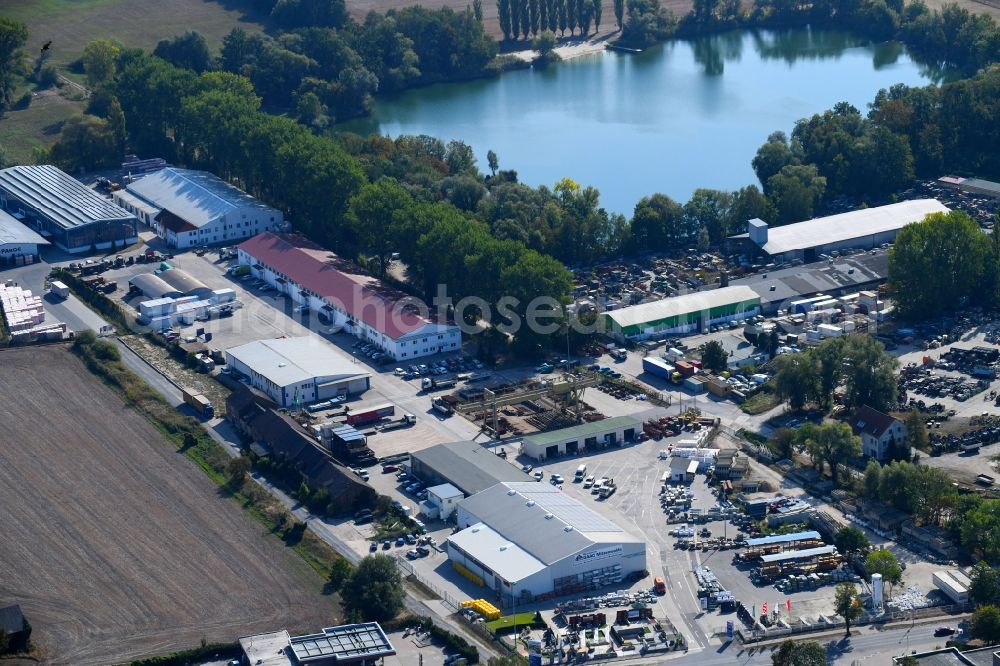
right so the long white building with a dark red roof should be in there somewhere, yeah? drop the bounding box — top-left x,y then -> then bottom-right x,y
238,233 -> 462,361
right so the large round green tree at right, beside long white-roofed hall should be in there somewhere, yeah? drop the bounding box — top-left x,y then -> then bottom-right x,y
889,210 -> 990,320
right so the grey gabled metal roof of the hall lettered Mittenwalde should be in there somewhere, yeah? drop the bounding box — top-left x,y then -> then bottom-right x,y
459,482 -> 640,564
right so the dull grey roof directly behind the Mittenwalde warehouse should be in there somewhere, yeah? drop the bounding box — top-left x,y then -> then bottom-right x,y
411,441 -> 532,495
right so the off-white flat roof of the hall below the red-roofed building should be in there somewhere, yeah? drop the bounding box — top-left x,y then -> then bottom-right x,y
226,336 -> 369,386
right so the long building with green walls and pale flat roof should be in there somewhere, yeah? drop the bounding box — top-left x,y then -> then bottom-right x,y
603,285 -> 760,340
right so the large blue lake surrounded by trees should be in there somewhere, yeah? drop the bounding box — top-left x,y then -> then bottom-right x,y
337,29 -> 938,214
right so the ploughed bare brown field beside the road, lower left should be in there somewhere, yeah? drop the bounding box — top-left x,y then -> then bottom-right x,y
0,347 -> 337,666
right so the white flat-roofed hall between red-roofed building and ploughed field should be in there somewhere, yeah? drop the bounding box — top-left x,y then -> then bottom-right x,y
226,336 -> 371,408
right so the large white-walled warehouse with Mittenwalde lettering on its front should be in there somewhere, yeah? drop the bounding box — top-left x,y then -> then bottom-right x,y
446,481 -> 647,607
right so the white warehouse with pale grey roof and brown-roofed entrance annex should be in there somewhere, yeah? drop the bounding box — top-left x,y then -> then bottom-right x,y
113,167 -> 284,249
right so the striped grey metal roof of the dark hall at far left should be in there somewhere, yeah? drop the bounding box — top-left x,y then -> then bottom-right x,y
0,164 -> 136,229
